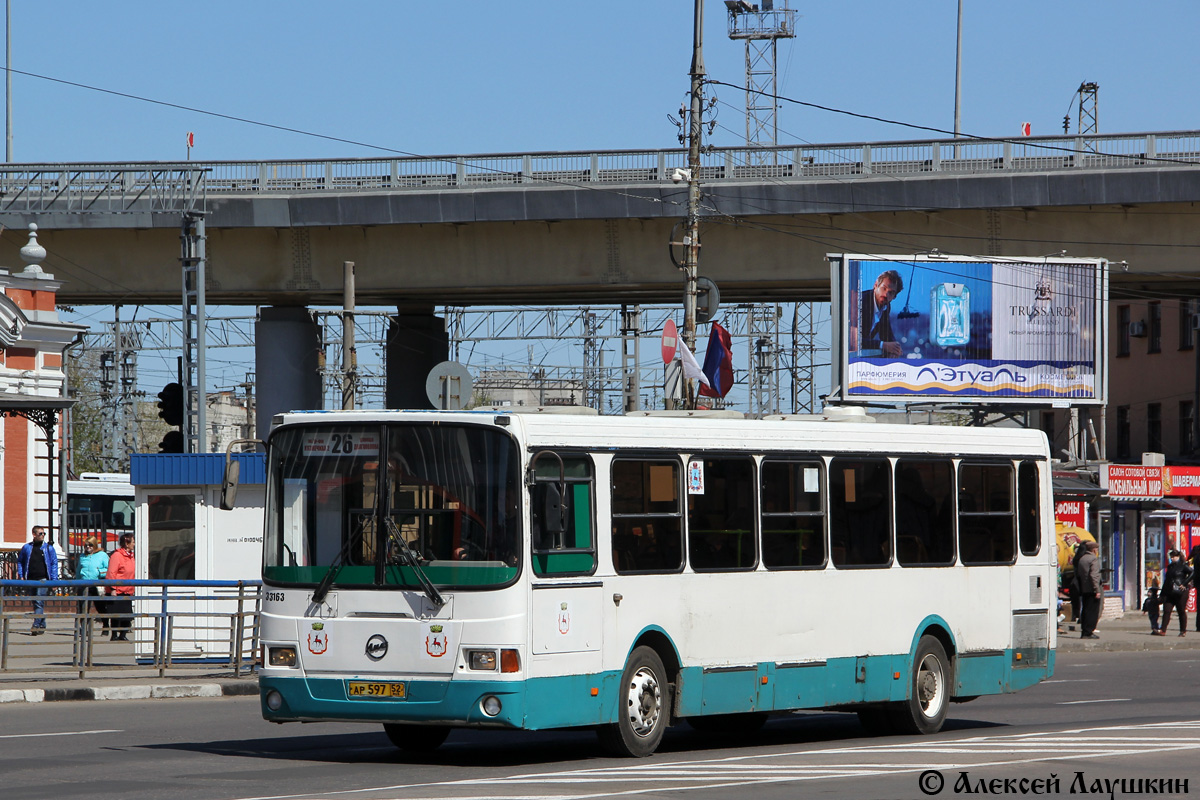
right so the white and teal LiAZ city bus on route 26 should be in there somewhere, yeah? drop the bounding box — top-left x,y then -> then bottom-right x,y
248,410 -> 1056,756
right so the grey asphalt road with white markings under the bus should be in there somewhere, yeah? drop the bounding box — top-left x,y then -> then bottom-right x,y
0,651 -> 1200,800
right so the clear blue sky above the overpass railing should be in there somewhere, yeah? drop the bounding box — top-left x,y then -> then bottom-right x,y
12,0 -> 1200,162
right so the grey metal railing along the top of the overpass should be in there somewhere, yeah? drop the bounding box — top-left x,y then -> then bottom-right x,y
0,131 -> 1200,205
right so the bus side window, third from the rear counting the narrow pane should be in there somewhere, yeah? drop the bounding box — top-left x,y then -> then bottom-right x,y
895,458 -> 954,566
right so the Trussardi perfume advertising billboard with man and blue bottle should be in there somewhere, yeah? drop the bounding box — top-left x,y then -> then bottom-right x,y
829,254 -> 1108,405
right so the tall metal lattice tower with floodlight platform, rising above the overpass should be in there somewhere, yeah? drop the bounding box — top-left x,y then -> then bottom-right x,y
725,0 -> 796,163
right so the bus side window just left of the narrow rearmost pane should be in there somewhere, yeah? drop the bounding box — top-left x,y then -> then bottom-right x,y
959,463 -> 1016,565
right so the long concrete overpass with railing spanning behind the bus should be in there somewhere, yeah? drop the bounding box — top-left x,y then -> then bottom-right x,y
9,131 -> 1200,312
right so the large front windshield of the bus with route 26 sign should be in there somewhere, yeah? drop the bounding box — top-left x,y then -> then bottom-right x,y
263,423 -> 522,589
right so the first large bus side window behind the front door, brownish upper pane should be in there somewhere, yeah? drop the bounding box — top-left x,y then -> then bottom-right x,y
612,458 -> 683,573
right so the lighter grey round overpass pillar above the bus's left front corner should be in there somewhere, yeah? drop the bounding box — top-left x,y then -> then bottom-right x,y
254,306 -> 322,439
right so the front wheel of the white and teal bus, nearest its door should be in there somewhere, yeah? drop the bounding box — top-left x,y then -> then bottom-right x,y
596,646 -> 671,758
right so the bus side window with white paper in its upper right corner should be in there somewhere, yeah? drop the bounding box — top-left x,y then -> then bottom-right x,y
760,459 -> 826,570
